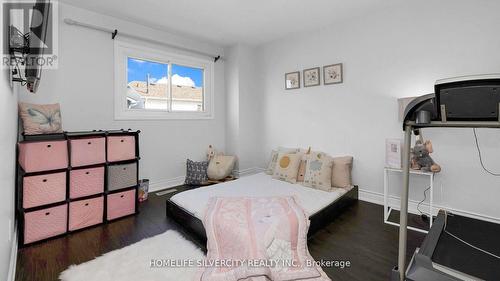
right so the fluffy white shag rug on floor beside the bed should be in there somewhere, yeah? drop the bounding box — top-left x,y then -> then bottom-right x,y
59,230 -> 204,281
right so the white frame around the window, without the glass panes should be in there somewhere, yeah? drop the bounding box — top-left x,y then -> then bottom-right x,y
114,40 -> 214,120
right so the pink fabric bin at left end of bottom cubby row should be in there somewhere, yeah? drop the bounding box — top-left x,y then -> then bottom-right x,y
24,204 -> 68,244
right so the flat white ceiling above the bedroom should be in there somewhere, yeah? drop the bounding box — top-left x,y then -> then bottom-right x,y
63,0 -> 400,45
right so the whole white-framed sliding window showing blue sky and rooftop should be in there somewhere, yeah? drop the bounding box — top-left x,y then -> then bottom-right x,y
115,41 -> 213,120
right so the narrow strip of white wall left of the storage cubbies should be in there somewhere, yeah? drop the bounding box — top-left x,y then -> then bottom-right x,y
0,1 -> 17,280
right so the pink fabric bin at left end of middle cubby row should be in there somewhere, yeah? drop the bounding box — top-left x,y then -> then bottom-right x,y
23,172 -> 66,208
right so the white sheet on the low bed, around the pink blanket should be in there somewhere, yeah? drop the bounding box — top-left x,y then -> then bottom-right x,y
170,173 -> 349,220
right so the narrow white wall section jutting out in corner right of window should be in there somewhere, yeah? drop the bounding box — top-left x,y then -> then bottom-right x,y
225,44 -> 263,174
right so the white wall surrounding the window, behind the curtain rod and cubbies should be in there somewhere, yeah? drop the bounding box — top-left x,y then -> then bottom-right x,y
19,4 -> 225,187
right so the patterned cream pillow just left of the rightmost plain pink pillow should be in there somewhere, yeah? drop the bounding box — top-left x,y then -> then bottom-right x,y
304,152 -> 333,191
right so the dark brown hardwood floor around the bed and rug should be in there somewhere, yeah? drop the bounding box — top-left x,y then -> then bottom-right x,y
16,187 -> 424,281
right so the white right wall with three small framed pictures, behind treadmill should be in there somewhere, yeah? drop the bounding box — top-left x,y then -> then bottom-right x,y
257,0 -> 500,218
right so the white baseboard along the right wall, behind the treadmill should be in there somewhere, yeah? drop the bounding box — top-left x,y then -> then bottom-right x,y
359,189 -> 500,224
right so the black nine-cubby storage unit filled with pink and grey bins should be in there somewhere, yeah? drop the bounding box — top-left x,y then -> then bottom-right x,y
16,129 -> 140,247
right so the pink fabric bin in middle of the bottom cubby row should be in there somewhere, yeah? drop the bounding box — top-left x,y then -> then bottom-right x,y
69,196 -> 104,230
